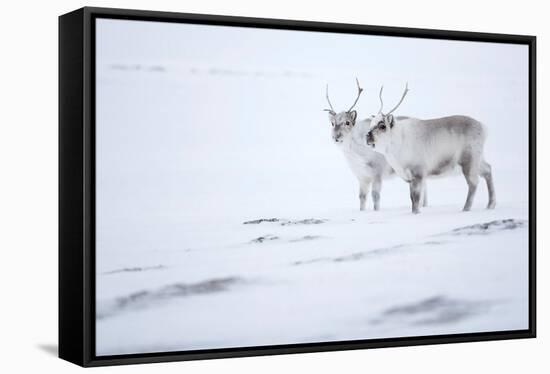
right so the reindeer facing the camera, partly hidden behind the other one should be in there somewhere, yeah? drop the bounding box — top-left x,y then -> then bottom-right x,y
325,78 -> 393,211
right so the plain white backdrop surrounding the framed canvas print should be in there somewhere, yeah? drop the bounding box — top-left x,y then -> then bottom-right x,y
0,0 -> 550,373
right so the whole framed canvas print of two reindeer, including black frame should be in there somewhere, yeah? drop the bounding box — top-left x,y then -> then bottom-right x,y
59,8 -> 536,366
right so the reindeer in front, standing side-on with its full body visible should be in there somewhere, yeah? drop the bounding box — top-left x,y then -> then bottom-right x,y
366,84 -> 496,214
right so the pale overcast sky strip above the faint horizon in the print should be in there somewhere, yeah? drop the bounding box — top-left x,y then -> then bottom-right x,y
97,19 -> 527,79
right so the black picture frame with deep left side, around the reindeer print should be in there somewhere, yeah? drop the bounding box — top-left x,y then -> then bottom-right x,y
59,7 -> 536,366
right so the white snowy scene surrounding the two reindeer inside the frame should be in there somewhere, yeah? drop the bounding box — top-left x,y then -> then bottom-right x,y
96,20 -> 529,355
